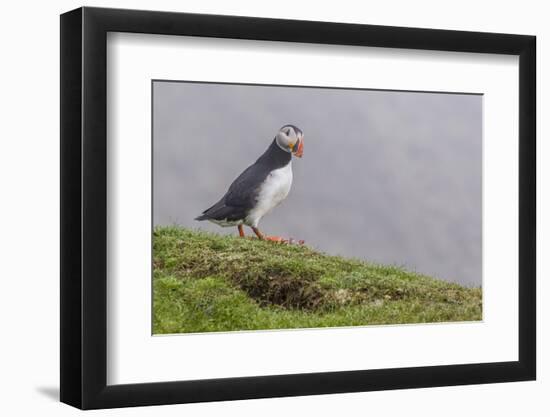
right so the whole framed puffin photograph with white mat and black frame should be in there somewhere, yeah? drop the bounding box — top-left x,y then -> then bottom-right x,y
60,7 -> 536,409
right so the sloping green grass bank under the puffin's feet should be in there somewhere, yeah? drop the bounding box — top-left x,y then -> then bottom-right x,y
153,227 -> 481,334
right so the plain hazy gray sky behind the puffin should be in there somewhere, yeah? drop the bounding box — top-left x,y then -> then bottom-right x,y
153,81 -> 482,285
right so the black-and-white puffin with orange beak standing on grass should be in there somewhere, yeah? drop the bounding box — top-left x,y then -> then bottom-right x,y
195,124 -> 304,243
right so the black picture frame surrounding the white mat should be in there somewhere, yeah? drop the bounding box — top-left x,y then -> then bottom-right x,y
60,7 -> 536,409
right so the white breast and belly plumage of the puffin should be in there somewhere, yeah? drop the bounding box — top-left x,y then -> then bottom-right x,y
245,162 -> 292,227
